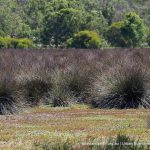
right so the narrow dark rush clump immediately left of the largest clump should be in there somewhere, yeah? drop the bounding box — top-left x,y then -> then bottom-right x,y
68,64 -> 94,103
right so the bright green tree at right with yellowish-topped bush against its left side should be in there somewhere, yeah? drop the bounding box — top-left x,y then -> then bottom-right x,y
106,12 -> 146,47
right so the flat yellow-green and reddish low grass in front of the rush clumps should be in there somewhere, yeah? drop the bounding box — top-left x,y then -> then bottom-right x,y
0,105 -> 150,150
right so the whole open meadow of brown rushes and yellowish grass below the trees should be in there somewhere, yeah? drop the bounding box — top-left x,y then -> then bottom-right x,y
0,49 -> 150,150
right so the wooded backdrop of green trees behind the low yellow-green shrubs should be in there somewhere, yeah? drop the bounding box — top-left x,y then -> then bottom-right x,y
0,0 -> 150,48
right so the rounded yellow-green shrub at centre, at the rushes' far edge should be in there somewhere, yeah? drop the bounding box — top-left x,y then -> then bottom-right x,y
67,30 -> 101,49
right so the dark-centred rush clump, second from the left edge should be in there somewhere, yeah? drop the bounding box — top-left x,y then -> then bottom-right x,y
18,71 -> 51,106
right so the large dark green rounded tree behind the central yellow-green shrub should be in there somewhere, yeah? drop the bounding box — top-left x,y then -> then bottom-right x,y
42,8 -> 84,47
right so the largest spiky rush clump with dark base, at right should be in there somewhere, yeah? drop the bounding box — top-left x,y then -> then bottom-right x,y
91,65 -> 150,109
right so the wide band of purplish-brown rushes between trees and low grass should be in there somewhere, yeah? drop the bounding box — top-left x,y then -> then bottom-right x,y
0,49 -> 150,113
